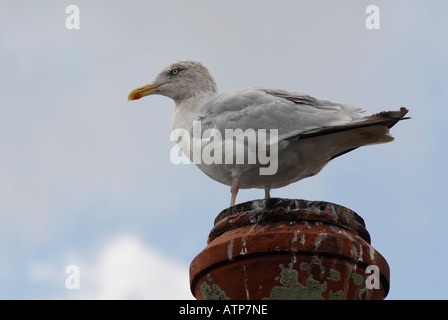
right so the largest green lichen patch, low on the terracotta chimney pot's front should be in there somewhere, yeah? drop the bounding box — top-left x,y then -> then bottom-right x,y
264,262 -> 327,300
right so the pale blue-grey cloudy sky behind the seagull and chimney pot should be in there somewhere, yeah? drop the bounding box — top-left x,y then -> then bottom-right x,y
0,0 -> 448,300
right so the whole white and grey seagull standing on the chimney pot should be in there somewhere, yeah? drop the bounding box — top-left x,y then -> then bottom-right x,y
128,60 -> 409,206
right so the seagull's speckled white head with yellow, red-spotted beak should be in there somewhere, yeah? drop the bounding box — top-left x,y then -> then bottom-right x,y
128,60 -> 217,103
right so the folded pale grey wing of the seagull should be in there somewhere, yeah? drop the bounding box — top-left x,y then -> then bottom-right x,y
199,88 -> 363,140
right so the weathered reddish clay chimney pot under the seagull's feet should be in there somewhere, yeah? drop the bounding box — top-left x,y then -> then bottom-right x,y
190,198 -> 389,299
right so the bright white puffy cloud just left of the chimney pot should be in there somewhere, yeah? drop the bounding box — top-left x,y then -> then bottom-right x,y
79,235 -> 193,299
